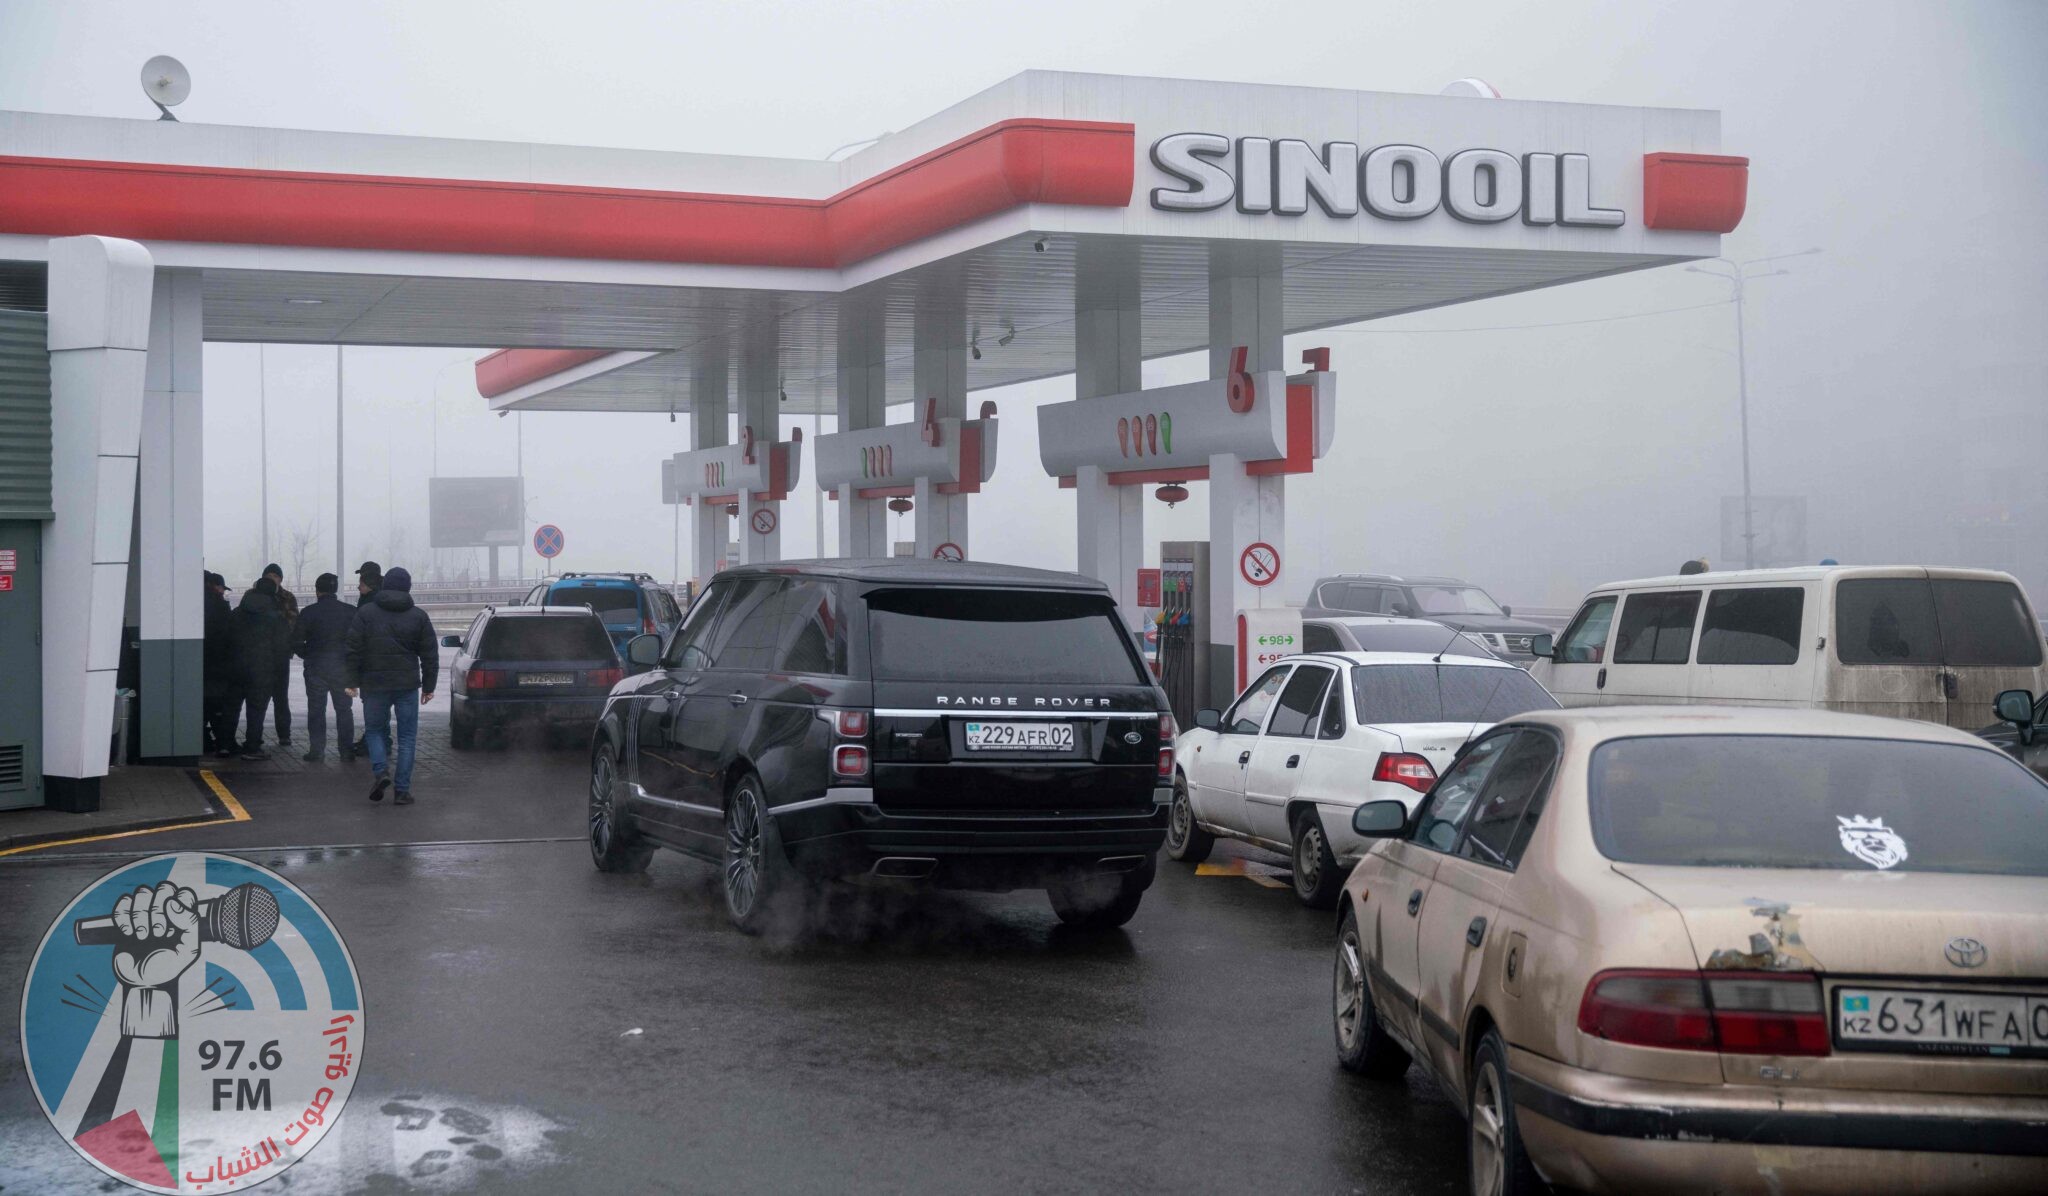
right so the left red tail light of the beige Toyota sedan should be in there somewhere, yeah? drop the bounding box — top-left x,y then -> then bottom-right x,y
1579,969 -> 1829,1055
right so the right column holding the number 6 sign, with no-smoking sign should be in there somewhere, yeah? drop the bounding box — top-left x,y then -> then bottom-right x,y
1208,246 -> 1288,709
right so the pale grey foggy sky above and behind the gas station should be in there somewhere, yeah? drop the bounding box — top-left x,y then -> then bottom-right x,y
0,0 -> 2048,606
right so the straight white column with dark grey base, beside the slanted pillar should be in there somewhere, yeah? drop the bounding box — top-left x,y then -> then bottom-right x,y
131,270 -> 207,758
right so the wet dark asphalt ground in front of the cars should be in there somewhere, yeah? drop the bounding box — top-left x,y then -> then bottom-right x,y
0,721 -> 1464,1194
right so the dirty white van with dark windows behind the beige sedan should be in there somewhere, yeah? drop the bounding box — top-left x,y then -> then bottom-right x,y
1530,565 -> 2048,731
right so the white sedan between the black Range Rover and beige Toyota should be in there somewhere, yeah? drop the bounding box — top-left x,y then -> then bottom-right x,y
1165,651 -> 1556,909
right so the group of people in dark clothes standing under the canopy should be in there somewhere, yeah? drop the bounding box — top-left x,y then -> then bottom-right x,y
205,561 -> 440,805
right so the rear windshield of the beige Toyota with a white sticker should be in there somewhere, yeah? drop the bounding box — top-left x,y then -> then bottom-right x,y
1587,735 -> 2048,877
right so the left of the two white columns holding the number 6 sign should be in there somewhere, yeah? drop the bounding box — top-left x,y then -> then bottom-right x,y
1073,244 -> 1145,631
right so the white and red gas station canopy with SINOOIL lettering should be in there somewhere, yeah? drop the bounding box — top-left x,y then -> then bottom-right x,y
0,72 -> 1747,414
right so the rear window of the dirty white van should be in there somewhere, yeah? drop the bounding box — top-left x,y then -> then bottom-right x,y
1835,578 -> 2042,668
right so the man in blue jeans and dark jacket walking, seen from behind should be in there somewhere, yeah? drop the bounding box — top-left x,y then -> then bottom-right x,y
348,567 -> 440,805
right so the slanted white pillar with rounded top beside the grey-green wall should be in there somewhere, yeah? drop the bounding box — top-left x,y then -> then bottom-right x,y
43,238 -> 154,809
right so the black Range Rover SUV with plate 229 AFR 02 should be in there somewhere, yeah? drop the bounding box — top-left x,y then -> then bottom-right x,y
590,559 -> 1174,932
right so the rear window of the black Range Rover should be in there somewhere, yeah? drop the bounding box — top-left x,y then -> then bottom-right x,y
866,588 -> 1149,686
